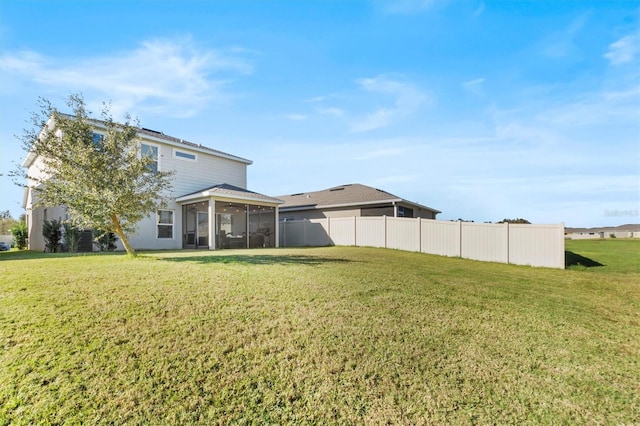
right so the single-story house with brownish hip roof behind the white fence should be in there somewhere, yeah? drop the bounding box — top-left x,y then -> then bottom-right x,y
277,183 -> 440,220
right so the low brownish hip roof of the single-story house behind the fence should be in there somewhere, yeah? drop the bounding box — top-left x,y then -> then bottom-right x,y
278,183 -> 441,213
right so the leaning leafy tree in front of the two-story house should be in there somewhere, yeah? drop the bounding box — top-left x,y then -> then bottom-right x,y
18,94 -> 173,255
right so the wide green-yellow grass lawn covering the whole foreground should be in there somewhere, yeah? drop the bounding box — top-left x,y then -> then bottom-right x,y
0,240 -> 640,424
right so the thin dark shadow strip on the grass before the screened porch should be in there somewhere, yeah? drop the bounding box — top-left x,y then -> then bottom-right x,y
159,254 -> 352,265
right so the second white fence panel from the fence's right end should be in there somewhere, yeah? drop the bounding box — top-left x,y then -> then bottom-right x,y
461,222 -> 509,263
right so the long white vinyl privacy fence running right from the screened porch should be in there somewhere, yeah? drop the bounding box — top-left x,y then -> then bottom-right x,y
279,216 -> 565,269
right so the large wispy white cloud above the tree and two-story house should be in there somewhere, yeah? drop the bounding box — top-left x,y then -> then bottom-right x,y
0,38 -> 252,116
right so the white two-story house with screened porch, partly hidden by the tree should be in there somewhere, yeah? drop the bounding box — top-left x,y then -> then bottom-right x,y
22,120 -> 282,250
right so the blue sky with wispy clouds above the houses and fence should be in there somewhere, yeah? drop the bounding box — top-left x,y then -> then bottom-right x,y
0,0 -> 640,226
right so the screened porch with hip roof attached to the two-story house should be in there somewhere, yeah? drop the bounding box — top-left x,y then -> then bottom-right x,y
176,184 -> 282,250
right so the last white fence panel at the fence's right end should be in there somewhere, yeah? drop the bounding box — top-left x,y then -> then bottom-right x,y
509,224 -> 564,269
